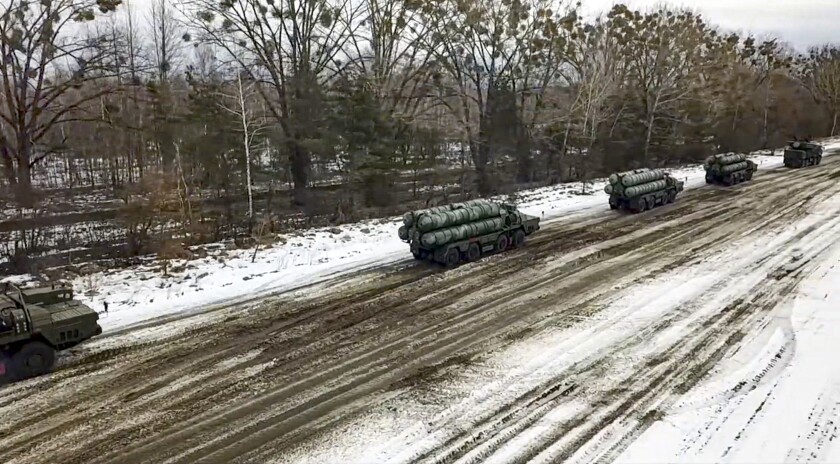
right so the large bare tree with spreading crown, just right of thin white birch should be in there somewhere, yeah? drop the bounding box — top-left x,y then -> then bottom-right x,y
182,0 -> 360,206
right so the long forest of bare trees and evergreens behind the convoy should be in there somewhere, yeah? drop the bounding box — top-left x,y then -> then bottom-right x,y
0,0 -> 840,272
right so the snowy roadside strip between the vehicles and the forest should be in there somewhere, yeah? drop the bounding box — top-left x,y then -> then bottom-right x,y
54,140 -> 840,332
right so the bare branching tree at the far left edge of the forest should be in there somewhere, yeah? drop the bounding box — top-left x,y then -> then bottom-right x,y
0,0 -> 120,205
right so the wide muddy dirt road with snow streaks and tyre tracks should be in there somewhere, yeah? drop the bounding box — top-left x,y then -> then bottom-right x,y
0,156 -> 840,464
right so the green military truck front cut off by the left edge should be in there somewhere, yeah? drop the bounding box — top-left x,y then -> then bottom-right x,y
0,283 -> 102,381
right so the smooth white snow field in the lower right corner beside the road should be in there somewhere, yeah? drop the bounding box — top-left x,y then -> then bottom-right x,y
618,217 -> 840,463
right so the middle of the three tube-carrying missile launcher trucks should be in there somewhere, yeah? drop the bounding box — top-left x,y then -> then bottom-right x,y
604,168 -> 683,213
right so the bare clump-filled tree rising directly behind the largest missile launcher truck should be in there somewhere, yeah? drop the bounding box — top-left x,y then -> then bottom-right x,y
424,0 -> 574,194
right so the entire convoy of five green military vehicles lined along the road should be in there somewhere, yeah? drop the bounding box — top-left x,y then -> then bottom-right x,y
0,140 -> 823,381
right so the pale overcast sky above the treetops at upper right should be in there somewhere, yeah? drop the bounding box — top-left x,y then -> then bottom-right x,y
582,0 -> 840,50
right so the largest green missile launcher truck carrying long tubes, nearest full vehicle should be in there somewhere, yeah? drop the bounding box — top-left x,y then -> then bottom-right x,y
398,200 -> 540,267
